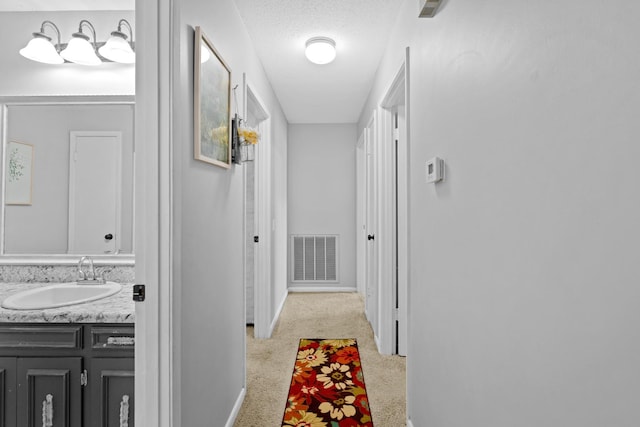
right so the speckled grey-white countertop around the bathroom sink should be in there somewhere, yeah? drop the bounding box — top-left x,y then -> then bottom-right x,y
0,283 -> 135,323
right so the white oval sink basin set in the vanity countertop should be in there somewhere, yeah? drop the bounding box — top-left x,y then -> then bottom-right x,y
2,282 -> 122,310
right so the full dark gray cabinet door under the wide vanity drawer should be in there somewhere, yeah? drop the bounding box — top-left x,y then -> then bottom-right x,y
17,357 -> 82,427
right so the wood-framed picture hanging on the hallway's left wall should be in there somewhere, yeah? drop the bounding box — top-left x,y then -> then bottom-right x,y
193,27 -> 231,169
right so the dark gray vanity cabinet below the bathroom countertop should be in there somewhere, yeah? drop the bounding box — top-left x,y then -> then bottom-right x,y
0,323 -> 134,427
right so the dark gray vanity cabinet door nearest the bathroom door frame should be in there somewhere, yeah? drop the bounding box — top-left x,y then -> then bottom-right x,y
87,358 -> 134,427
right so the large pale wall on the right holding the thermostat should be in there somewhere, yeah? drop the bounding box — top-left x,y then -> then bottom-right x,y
359,0 -> 640,427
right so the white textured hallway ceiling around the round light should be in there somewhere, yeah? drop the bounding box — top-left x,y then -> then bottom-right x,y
235,0 -> 403,123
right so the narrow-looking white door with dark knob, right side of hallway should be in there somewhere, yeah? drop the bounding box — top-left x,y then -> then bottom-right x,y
365,116 -> 379,338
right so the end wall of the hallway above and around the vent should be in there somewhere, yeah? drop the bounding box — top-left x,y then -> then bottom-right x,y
288,124 -> 358,290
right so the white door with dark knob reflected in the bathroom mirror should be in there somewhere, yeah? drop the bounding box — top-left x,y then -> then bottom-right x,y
68,131 -> 122,254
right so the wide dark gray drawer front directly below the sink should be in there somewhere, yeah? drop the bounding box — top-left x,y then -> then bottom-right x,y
0,326 -> 82,349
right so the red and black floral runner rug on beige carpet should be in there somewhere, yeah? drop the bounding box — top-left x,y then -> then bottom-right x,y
282,339 -> 373,427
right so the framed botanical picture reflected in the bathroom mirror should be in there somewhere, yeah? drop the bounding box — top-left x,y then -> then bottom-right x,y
4,141 -> 33,205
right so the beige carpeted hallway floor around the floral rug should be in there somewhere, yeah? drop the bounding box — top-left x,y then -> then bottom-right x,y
234,293 -> 406,427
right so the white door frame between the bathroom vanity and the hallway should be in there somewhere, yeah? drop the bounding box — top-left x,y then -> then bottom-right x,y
135,0 -> 174,427
